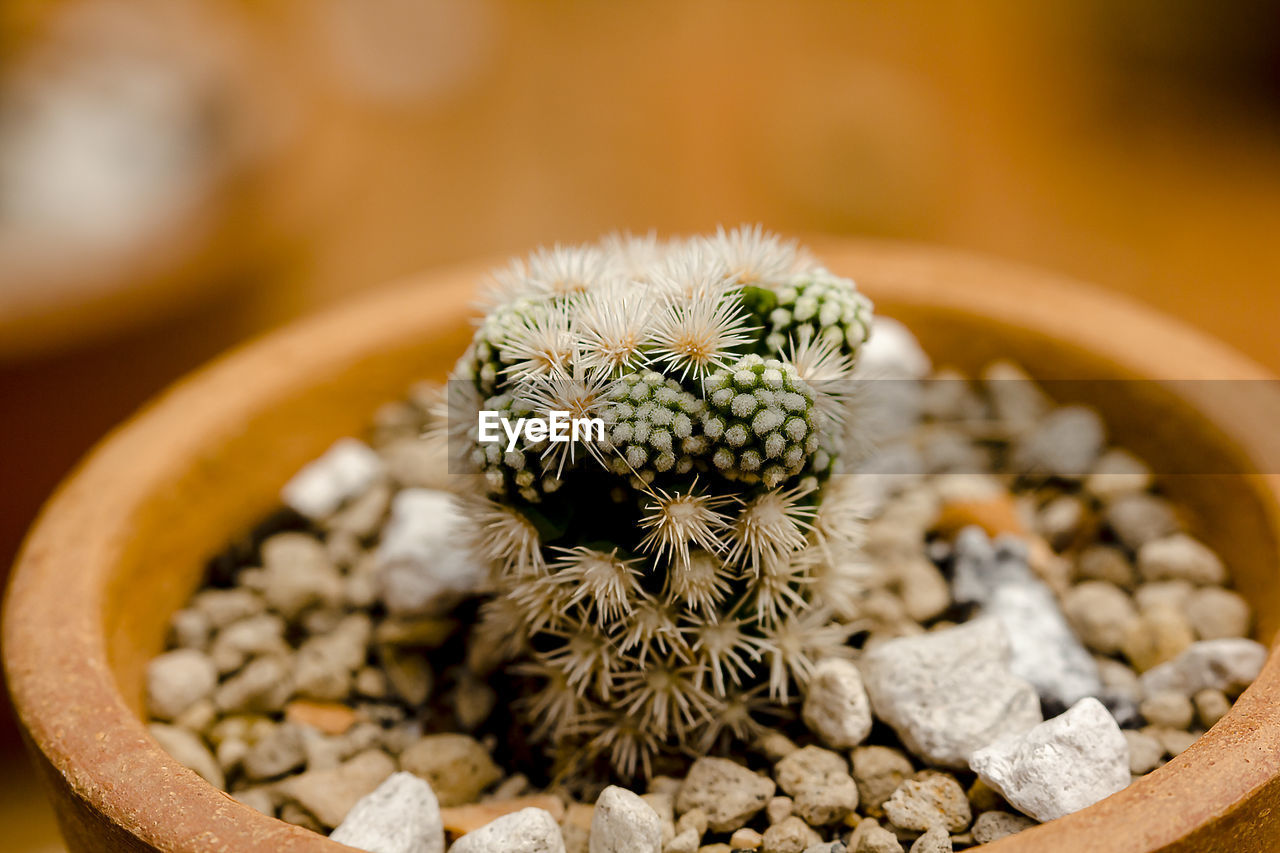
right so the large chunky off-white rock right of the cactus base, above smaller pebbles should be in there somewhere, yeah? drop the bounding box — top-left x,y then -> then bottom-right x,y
863,619 -> 1041,767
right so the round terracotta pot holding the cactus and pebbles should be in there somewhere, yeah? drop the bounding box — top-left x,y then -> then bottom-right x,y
4,241 -> 1280,853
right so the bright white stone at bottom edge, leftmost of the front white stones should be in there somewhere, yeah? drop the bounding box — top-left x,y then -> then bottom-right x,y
330,772 -> 444,853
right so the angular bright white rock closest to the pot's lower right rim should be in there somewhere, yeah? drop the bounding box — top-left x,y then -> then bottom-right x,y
970,698 -> 1129,821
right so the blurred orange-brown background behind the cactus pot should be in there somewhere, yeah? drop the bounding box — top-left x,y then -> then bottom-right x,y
0,0 -> 1280,850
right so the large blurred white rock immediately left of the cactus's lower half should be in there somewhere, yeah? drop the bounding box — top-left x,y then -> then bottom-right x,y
376,489 -> 489,615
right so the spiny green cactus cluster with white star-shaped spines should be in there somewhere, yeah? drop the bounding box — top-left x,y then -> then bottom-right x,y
449,227 -> 870,776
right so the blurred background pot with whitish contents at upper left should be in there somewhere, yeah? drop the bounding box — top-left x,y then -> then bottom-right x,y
0,0 -> 291,359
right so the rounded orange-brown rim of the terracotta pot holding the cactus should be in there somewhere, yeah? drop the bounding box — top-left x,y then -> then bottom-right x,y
3,237 -> 1280,853
